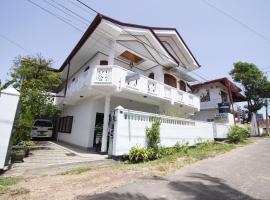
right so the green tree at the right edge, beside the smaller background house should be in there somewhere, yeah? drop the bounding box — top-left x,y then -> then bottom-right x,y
230,62 -> 270,116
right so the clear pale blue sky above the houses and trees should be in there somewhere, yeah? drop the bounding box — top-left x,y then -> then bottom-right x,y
0,0 -> 270,114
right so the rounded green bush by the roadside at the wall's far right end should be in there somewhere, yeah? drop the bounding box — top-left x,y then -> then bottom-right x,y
227,126 -> 249,143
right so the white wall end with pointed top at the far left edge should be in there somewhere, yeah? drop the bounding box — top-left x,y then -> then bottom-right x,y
0,88 -> 20,169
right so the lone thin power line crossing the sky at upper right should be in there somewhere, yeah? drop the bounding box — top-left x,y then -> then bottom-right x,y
201,0 -> 270,43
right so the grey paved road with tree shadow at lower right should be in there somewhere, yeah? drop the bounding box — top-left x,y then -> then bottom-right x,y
78,139 -> 270,200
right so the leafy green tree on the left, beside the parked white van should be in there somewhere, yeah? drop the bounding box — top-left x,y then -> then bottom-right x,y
5,55 -> 61,143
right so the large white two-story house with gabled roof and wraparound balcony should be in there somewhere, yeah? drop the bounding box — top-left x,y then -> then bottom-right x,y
57,15 -> 200,155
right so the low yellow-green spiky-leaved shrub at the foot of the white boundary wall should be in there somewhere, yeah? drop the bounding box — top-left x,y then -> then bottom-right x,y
129,146 -> 152,163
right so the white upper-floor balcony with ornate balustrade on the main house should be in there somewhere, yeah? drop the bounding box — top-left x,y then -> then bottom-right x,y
61,65 -> 200,111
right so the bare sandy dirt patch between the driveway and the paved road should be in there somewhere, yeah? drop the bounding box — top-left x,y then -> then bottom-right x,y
0,168 -> 145,200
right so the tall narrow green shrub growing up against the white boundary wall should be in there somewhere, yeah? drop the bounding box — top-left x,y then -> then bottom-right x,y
146,120 -> 160,149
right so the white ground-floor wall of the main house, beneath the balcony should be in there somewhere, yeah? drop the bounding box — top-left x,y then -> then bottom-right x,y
58,97 -> 158,148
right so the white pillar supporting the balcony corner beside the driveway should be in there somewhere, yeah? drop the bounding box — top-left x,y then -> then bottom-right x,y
101,95 -> 111,152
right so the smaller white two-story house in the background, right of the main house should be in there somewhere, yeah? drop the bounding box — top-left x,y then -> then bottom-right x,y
191,77 -> 245,124
